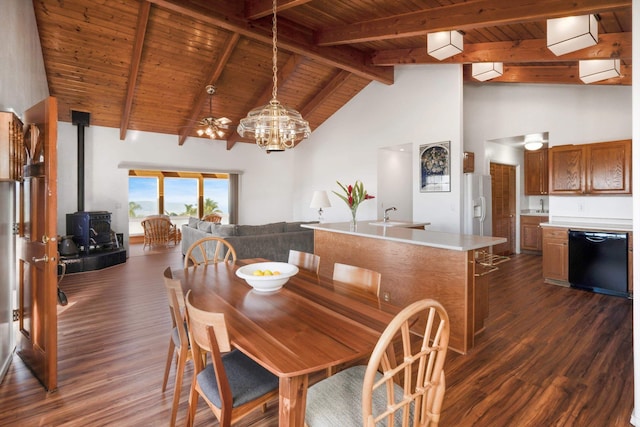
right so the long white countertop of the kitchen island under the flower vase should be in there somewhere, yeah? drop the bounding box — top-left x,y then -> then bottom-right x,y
301,221 -> 507,251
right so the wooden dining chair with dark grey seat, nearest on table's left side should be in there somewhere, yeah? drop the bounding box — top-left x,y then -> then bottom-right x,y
186,291 -> 279,427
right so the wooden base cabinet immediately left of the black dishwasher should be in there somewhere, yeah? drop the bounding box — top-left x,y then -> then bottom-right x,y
542,227 -> 569,285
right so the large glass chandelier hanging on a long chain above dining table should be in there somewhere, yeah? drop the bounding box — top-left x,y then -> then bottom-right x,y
238,0 -> 311,153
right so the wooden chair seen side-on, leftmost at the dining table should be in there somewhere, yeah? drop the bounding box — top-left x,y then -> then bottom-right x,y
162,267 -> 192,426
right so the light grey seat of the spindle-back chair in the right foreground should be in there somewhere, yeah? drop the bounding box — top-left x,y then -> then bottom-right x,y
305,366 -> 413,427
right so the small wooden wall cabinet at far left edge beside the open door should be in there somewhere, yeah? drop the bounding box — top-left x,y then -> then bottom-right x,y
0,112 -> 25,181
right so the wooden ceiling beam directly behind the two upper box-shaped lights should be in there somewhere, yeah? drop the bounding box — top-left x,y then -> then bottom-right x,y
371,33 -> 631,66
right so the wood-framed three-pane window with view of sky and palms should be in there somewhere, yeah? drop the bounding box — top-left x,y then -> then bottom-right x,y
129,170 -> 238,235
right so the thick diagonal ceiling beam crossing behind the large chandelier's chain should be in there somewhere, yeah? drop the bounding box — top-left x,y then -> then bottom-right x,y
149,0 -> 394,85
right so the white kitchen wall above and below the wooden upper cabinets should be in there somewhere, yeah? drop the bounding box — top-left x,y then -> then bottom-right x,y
464,84 -> 633,223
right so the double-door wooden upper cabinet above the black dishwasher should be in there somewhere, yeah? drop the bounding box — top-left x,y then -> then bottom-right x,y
549,139 -> 631,195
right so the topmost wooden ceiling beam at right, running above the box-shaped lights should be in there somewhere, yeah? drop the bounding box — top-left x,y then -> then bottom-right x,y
315,0 -> 632,46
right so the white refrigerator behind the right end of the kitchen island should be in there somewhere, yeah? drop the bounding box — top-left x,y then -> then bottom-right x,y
463,173 -> 492,236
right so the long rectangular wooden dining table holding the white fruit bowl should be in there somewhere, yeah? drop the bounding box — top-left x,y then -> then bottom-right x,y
173,259 -> 401,426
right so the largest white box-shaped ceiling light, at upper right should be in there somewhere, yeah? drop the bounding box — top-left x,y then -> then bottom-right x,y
547,15 -> 598,56
